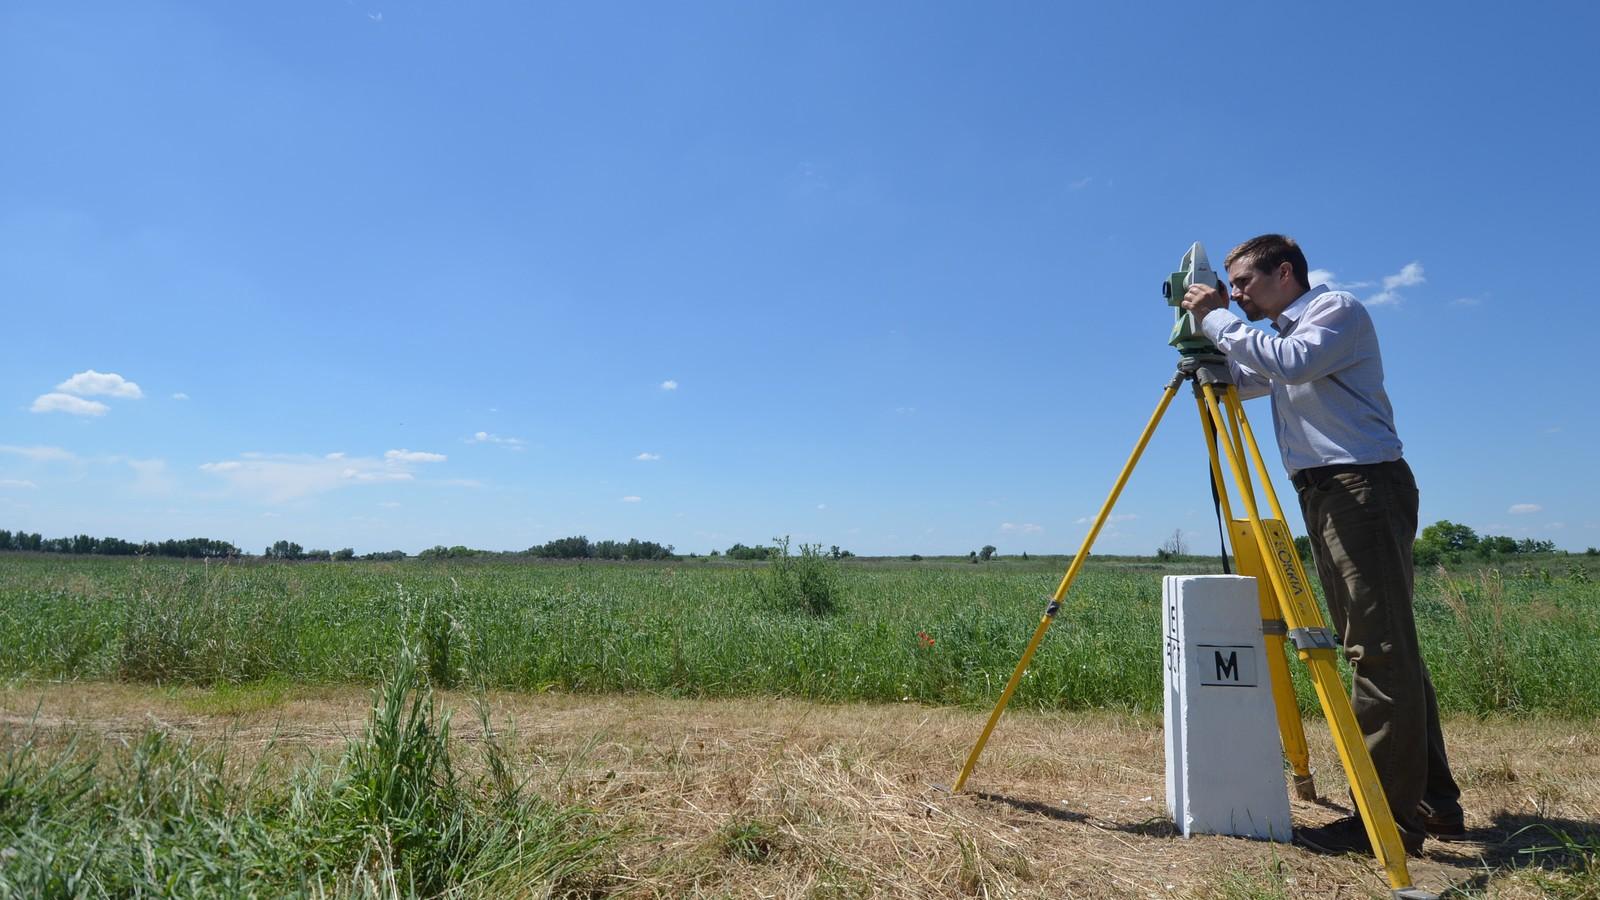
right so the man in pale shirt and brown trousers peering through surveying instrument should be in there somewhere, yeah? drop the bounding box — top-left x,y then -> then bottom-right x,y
1182,234 -> 1464,855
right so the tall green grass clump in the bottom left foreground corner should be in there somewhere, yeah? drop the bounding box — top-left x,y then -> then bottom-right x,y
0,634 -> 610,897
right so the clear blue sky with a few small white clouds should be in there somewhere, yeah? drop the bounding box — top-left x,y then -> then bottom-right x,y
0,0 -> 1600,554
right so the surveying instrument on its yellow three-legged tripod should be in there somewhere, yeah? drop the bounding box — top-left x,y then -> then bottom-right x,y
952,242 -> 1434,900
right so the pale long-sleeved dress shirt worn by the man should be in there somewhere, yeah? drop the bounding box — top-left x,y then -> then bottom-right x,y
1200,285 -> 1400,476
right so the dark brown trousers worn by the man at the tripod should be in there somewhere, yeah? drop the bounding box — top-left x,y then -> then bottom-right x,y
1299,460 -> 1461,838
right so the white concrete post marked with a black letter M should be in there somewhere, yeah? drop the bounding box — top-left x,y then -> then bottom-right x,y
1162,575 -> 1291,842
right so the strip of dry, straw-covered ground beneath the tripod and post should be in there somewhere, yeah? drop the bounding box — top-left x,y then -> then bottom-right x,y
0,684 -> 1600,898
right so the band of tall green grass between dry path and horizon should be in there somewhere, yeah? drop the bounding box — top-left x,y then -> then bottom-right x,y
0,554 -> 1600,716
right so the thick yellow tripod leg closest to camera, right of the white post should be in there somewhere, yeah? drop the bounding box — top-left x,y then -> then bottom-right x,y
1205,384 -> 1411,894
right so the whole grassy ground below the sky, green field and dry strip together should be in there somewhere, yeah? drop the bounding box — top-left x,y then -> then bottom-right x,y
0,554 -> 1600,900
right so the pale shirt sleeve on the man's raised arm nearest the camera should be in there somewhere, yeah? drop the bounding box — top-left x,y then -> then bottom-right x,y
1200,299 -> 1366,384
